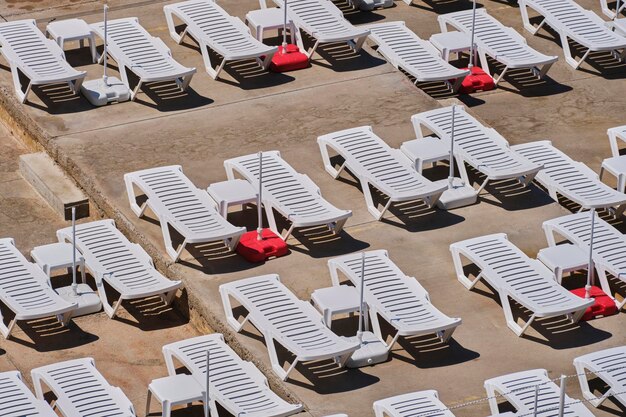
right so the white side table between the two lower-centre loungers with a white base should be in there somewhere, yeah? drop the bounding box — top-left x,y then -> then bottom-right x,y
311,285 -> 369,330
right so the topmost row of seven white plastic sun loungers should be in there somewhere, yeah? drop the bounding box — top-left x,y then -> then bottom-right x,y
0,0 -> 626,102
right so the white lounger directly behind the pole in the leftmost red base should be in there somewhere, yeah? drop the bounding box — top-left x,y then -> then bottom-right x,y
224,151 -> 352,240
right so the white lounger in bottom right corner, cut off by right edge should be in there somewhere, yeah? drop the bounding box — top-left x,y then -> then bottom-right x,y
574,346 -> 626,407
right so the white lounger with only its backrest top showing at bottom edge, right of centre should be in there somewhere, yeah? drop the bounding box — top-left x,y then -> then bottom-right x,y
374,390 -> 454,417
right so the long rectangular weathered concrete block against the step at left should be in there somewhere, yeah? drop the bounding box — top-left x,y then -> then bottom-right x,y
20,152 -> 89,220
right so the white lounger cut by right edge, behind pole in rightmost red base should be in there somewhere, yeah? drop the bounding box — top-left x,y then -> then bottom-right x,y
543,213 -> 626,309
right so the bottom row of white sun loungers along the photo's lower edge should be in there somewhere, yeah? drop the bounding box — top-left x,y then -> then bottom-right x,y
6,342 -> 626,417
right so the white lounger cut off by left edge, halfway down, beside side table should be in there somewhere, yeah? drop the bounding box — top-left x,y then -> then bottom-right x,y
0,238 -> 78,339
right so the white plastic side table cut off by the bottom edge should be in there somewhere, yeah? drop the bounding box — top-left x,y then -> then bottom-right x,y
146,374 -> 209,417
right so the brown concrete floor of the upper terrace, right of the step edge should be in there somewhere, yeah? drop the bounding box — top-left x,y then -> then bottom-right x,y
0,0 -> 626,416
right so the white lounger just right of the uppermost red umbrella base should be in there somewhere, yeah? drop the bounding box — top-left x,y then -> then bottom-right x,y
270,0 -> 370,57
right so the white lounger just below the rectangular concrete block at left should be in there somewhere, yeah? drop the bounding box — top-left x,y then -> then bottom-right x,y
57,220 -> 182,318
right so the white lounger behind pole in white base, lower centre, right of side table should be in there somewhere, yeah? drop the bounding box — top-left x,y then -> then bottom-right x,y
328,250 -> 461,350
